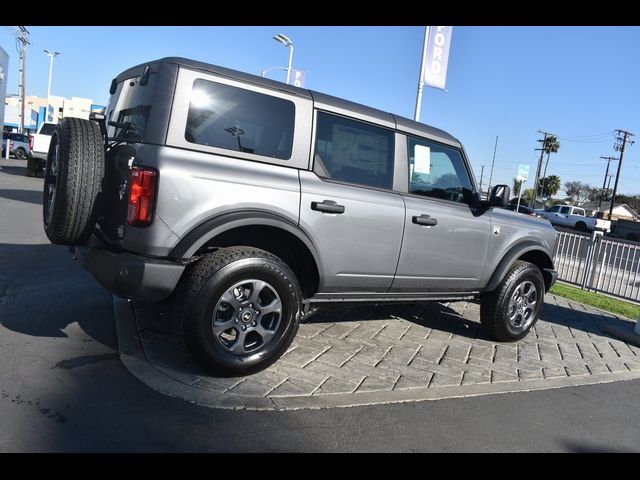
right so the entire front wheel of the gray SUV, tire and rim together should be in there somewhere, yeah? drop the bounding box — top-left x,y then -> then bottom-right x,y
480,260 -> 545,342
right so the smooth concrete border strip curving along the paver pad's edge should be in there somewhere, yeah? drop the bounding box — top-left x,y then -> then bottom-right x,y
113,297 -> 640,410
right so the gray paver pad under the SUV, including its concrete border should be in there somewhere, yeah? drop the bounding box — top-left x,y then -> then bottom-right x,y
114,295 -> 640,409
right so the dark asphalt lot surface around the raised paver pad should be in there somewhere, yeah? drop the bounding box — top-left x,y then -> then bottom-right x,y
0,159 -> 640,452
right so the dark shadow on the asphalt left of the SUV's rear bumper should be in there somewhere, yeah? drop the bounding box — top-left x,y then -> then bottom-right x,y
0,244 -> 117,349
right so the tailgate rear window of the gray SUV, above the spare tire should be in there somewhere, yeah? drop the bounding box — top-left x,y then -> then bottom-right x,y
107,75 -> 157,142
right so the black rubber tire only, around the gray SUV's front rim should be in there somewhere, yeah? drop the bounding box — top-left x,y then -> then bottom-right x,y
480,260 -> 545,342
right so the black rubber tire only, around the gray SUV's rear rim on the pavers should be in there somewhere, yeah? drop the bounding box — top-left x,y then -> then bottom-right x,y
174,247 -> 302,376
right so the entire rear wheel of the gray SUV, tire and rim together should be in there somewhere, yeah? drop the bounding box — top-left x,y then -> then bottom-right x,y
177,247 -> 301,376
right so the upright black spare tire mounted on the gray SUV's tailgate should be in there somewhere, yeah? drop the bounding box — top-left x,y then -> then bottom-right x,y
42,118 -> 104,245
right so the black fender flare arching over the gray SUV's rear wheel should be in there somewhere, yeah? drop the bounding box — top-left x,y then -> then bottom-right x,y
169,210 -> 322,278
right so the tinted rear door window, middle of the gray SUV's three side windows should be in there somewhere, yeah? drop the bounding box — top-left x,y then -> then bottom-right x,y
314,112 -> 394,189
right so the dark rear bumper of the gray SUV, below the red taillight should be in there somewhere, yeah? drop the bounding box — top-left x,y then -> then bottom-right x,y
71,236 -> 185,302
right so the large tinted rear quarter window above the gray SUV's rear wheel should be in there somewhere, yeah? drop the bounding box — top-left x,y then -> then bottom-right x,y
184,79 -> 295,160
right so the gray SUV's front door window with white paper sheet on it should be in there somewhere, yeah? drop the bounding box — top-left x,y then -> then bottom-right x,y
408,137 -> 473,204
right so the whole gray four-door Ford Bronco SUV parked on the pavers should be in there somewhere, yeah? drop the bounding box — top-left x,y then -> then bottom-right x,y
43,58 -> 556,375
